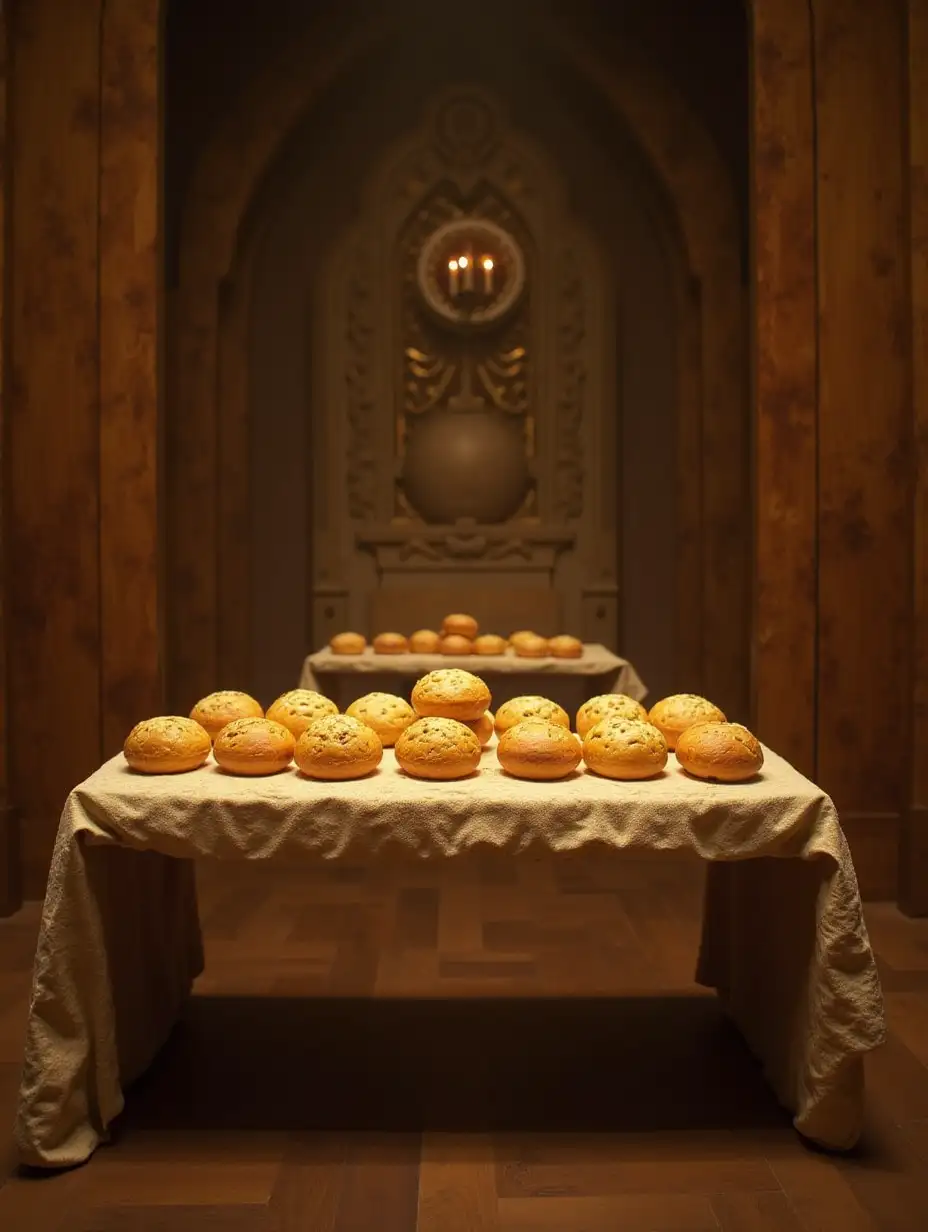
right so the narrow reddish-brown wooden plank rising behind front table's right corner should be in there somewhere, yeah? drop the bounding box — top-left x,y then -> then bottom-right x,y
751,0 -> 817,776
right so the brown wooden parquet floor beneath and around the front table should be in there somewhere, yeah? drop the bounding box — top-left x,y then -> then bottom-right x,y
0,856 -> 928,1232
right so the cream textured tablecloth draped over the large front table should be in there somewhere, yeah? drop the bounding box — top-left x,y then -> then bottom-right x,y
16,750 -> 885,1167
